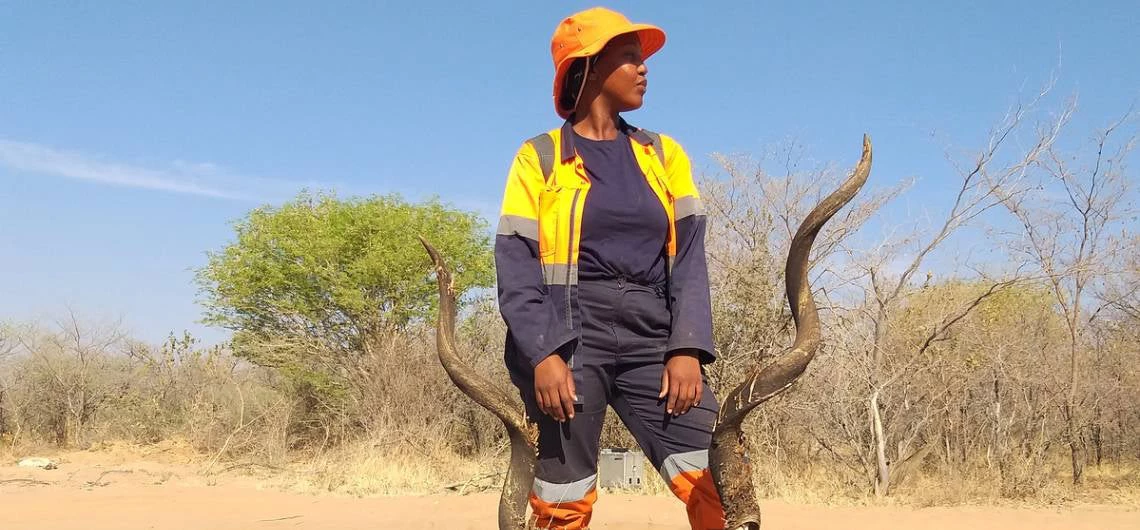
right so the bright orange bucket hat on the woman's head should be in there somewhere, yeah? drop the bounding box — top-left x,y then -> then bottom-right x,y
551,7 -> 665,119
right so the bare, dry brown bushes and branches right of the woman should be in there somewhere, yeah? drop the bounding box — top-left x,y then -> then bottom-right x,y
684,89 -> 1140,504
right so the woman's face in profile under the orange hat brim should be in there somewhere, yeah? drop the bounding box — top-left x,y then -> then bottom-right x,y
591,33 -> 649,112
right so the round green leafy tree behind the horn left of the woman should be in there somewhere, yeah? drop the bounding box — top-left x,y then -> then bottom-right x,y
197,193 -> 494,421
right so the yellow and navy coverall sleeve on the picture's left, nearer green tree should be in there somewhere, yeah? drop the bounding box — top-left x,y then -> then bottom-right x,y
495,144 -> 576,369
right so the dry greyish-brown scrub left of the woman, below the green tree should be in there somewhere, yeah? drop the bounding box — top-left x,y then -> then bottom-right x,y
0,301 -> 511,491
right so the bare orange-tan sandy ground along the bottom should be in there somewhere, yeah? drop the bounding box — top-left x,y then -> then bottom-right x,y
0,451 -> 1140,530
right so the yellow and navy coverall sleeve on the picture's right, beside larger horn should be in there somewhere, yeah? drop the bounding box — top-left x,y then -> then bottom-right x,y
661,134 -> 716,364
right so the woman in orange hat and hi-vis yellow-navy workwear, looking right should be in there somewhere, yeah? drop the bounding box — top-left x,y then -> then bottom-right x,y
495,8 -> 724,530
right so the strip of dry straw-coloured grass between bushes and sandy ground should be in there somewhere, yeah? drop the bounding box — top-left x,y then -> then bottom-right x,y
0,433 -> 1140,508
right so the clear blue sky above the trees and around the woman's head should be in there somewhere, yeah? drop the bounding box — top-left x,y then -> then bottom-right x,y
0,0 -> 1140,341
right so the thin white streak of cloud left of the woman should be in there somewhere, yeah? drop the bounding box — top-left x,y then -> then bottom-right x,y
0,139 -> 300,201
